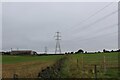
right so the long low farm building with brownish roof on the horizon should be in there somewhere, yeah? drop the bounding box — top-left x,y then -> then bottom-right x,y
10,50 -> 37,55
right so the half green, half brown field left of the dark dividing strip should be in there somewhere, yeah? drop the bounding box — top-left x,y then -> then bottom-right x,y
2,55 -> 63,78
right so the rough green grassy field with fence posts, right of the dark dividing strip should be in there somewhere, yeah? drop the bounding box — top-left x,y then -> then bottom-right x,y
60,53 -> 118,78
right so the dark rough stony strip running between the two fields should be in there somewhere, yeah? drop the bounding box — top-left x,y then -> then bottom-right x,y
38,56 -> 67,78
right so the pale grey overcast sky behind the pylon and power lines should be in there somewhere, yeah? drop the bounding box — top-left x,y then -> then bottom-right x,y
2,2 -> 118,52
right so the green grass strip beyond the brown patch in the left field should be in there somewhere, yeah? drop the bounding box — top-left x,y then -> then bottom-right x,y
2,55 -> 63,64
